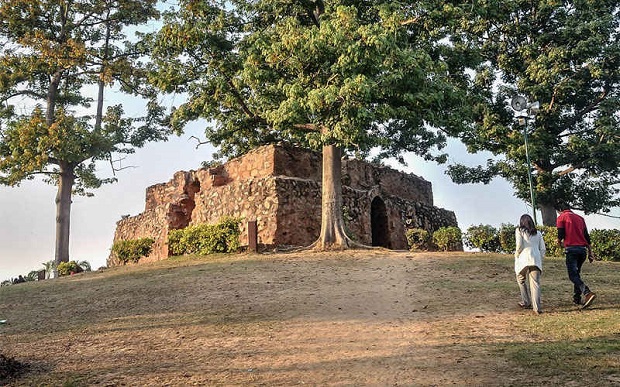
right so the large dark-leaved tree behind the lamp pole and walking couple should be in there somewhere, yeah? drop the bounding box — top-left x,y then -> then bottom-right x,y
449,0 -> 620,225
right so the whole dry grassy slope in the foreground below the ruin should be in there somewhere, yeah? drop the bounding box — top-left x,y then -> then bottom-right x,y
0,250 -> 620,386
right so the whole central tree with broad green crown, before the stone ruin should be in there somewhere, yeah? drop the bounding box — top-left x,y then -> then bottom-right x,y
153,0 -> 468,249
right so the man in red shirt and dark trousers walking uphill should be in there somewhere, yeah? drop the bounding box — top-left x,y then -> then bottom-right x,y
556,202 -> 596,308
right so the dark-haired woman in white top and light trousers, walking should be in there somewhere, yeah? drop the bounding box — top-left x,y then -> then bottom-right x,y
515,214 -> 546,314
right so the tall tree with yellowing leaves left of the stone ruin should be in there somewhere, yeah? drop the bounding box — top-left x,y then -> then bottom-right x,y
0,0 -> 165,263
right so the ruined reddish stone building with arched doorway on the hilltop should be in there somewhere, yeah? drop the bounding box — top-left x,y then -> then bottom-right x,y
108,145 -> 457,266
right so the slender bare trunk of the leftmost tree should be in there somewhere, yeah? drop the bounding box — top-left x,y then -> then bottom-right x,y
54,163 -> 75,265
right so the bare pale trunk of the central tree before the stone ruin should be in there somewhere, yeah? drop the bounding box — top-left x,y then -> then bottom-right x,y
311,145 -> 356,250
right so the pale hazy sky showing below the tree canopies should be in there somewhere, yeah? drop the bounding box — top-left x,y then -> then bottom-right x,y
0,125 -> 620,281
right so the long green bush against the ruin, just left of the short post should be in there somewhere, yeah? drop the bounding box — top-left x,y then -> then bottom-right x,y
168,217 -> 241,255
